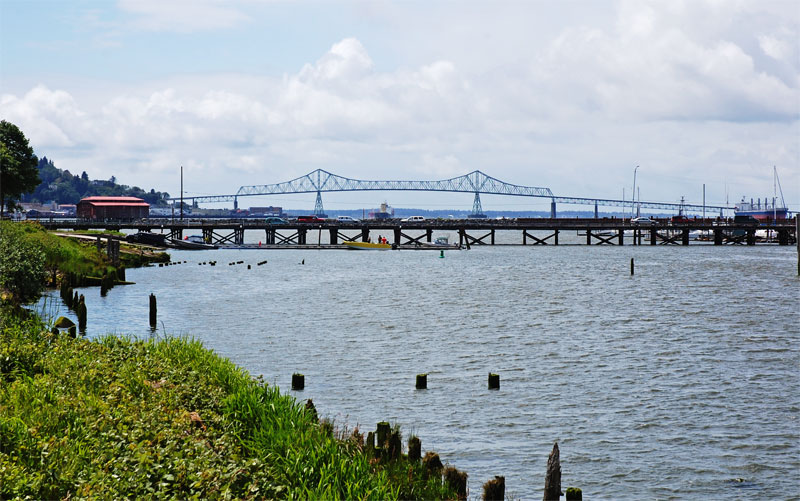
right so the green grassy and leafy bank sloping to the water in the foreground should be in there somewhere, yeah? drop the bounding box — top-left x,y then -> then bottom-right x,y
0,224 -> 466,499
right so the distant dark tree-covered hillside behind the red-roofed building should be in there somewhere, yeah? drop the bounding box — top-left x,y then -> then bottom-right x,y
22,157 -> 169,206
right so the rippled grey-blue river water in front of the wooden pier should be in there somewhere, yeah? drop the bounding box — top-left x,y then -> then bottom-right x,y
40,235 -> 800,499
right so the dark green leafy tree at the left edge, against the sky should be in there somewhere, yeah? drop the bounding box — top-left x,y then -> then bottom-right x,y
0,120 -> 39,214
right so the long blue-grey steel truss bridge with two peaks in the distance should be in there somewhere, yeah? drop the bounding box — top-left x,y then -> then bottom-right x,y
171,169 -> 732,217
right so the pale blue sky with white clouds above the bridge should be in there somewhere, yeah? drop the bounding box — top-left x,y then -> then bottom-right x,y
0,0 -> 800,210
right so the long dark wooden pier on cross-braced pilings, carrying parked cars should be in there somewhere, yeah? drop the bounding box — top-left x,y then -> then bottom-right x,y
39,218 -> 797,248
